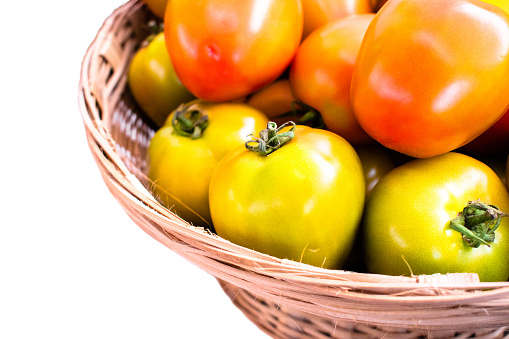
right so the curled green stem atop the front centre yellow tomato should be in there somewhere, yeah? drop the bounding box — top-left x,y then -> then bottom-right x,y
246,121 -> 296,155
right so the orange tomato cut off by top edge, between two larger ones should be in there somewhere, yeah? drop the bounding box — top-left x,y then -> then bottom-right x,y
301,0 -> 373,38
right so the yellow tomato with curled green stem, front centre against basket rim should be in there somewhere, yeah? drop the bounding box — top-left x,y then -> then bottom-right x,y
209,122 -> 365,268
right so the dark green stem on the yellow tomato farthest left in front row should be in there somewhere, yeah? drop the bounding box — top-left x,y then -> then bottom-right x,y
171,101 -> 209,139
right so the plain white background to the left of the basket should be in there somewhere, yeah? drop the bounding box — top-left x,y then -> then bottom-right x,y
0,0 -> 267,339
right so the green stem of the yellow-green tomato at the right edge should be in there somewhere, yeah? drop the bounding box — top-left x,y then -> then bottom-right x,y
450,200 -> 509,248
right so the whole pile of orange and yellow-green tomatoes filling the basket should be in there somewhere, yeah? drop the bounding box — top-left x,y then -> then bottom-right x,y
128,0 -> 509,281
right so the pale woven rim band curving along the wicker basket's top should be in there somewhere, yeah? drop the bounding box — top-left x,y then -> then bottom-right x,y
78,0 -> 509,334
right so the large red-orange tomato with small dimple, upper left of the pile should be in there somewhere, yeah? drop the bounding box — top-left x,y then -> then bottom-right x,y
164,0 -> 303,101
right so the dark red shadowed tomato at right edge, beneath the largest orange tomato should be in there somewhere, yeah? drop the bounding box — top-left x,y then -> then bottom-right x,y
462,110 -> 509,155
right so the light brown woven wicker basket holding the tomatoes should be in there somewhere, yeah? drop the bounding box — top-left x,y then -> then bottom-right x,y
79,0 -> 509,338
